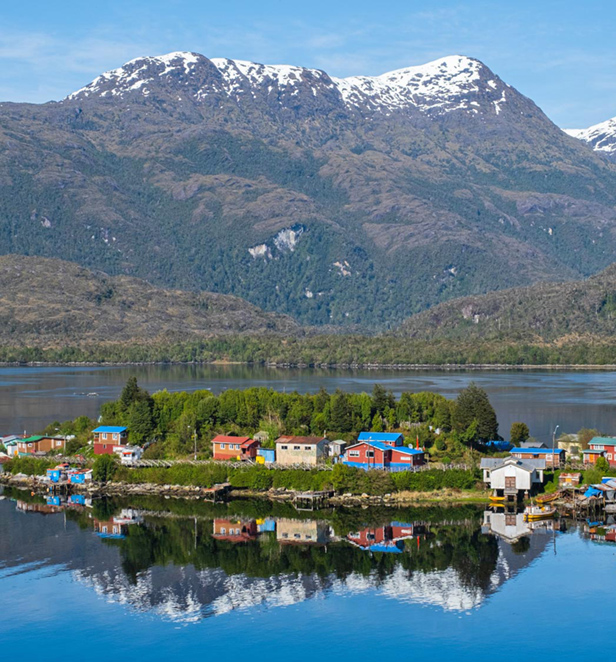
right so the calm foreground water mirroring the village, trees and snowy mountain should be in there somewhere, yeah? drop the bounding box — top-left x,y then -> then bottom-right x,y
0,491 -> 616,662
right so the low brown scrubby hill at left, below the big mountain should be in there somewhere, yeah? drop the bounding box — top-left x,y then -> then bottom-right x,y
0,255 -> 298,346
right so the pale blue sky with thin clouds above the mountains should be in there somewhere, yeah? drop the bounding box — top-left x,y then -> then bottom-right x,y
0,0 -> 616,128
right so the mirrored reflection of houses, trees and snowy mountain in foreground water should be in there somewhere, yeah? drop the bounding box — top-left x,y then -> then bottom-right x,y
0,490 -> 552,623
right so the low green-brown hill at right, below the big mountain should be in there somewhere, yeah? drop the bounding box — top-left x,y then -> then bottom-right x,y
396,264 -> 616,342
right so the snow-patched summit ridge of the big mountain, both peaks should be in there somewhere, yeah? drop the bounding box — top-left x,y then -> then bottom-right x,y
67,52 -> 512,120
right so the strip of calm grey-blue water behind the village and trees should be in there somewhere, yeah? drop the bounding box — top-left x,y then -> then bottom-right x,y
0,366 -> 616,441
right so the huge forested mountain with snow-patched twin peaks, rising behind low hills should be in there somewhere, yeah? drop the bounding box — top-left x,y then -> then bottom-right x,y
0,53 -> 616,329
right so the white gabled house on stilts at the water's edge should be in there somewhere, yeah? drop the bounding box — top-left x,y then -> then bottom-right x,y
481,456 -> 546,498
